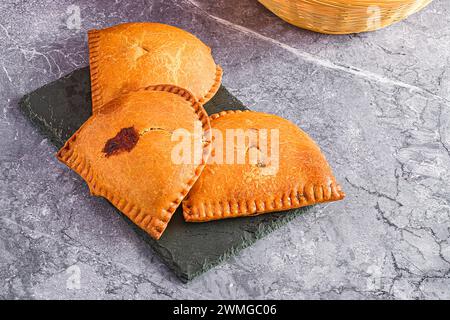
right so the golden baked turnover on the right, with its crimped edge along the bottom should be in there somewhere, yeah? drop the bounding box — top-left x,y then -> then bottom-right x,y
183,111 -> 345,222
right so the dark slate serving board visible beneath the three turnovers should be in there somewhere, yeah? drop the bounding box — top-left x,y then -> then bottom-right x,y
19,67 -> 308,282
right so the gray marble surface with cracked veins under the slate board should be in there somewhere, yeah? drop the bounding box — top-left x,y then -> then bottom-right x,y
0,0 -> 450,299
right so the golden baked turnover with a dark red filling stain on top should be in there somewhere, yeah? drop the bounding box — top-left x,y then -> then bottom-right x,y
57,85 -> 210,239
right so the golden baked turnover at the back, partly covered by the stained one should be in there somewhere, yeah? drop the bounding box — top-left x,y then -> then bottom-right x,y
88,22 -> 222,114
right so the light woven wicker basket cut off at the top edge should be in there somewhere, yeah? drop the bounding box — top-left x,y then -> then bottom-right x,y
259,0 -> 432,34
